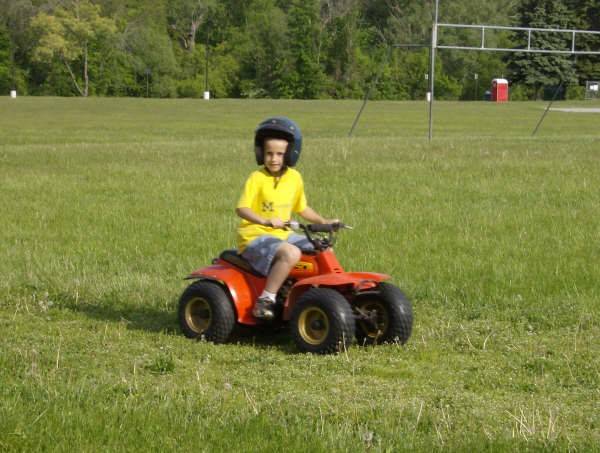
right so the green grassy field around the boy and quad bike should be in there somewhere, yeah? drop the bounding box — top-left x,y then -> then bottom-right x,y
0,98 -> 600,452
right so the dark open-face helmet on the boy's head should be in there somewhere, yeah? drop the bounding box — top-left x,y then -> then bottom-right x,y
254,116 -> 302,167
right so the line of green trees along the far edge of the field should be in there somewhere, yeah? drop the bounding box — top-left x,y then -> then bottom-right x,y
0,0 -> 600,100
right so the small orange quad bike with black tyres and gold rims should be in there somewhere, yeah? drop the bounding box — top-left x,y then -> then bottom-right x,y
179,222 -> 413,354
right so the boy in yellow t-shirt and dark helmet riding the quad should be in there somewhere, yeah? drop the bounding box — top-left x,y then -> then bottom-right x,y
236,117 -> 338,320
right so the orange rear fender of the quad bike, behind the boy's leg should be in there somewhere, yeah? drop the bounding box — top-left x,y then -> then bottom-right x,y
186,264 -> 265,325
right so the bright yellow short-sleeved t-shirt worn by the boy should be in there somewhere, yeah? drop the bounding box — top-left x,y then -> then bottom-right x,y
237,167 -> 307,252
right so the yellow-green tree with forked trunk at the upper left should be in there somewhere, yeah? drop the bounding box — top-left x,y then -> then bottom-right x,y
31,0 -> 116,97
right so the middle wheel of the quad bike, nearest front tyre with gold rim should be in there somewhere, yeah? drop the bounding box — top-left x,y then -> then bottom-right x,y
291,288 -> 355,354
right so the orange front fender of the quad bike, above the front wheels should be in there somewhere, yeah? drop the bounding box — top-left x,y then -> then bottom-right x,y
283,272 -> 390,321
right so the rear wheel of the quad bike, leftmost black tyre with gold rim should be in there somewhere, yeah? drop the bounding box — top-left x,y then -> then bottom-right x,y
179,280 -> 235,343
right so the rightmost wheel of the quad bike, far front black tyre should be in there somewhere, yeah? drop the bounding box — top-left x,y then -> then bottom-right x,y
353,283 -> 413,344
